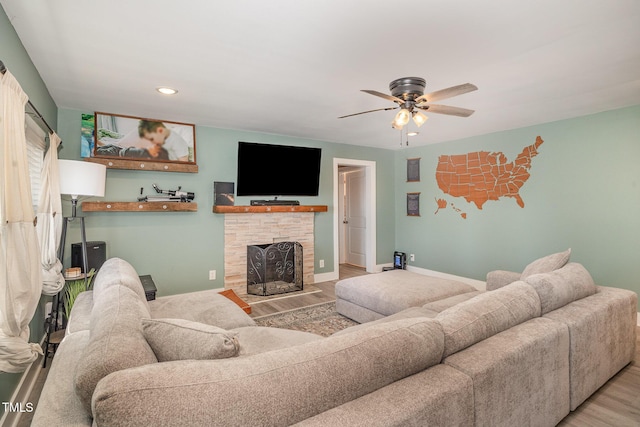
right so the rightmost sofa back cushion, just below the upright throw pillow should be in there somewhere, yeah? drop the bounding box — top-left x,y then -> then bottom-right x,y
525,262 -> 596,314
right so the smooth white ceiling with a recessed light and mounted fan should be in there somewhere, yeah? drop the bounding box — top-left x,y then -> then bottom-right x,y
0,0 -> 640,149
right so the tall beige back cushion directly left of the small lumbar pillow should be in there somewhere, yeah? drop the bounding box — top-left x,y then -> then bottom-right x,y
75,286 -> 158,413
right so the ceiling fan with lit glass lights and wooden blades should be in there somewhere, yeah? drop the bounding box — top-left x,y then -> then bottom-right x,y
338,77 -> 478,129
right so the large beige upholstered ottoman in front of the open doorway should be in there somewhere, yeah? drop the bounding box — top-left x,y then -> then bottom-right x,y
336,270 -> 477,323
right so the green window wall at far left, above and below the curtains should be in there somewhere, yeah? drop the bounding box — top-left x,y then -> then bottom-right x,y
0,4 -> 58,412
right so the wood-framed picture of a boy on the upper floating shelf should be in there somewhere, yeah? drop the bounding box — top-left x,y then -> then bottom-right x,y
92,112 -> 196,164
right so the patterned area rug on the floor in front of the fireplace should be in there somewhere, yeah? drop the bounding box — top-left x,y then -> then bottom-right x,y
253,301 -> 358,337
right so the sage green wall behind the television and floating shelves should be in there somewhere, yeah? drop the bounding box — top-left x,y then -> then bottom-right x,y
58,109 -> 395,295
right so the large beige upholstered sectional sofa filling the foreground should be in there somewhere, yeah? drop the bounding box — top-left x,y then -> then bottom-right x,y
33,252 -> 637,426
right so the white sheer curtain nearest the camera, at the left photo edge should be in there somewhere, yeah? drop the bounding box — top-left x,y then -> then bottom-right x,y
0,71 -> 42,372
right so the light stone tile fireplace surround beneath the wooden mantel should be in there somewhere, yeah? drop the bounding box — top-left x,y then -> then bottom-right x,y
224,212 -> 315,295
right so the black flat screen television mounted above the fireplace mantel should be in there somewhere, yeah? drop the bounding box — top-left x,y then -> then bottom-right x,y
236,141 -> 322,197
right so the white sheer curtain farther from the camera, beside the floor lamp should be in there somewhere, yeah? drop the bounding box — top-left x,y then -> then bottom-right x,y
36,133 -> 64,295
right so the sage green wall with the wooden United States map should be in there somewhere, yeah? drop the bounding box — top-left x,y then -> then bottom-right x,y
395,106 -> 640,310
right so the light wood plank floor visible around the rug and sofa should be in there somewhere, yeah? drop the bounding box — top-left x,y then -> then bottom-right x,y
17,265 -> 640,427
